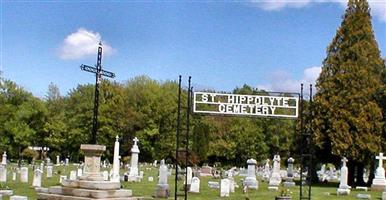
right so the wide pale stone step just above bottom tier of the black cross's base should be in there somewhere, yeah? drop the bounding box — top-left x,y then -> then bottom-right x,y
48,186 -> 132,199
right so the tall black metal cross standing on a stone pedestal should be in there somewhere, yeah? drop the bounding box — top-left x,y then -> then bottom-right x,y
80,42 -> 115,144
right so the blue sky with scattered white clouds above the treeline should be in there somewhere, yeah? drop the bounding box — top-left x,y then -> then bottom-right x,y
0,0 -> 386,97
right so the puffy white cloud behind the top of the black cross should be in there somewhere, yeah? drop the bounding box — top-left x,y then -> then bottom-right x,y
59,28 -> 115,60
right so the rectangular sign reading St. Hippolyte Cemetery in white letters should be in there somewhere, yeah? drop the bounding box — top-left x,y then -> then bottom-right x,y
193,92 -> 299,118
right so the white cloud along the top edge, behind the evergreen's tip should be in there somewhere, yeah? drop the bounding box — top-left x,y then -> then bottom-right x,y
251,0 -> 386,22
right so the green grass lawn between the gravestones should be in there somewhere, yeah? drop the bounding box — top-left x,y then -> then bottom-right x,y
3,165 -> 382,200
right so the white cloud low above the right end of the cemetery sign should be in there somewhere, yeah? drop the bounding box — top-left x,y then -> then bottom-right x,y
257,67 -> 322,93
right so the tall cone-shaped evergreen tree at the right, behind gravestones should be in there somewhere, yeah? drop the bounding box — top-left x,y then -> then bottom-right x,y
313,0 -> 385,184
